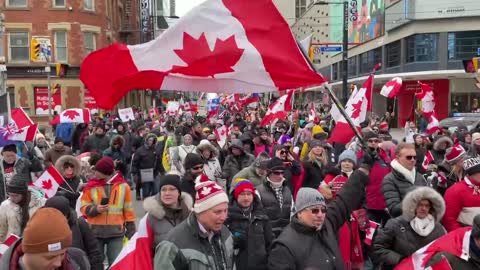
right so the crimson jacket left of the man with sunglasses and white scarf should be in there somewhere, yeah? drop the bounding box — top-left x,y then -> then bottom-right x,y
357,148 -> 392,210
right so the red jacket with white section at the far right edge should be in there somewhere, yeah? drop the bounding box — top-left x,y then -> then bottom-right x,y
442,178 -> 480,232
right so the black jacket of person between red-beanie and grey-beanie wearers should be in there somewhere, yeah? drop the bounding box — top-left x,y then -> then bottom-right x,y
257,181 -> 293,237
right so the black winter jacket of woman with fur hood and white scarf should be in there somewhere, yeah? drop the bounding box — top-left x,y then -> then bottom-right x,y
372,216 -> 446,270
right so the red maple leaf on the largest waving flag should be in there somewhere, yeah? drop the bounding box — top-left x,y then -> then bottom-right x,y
170,33 -> 244,77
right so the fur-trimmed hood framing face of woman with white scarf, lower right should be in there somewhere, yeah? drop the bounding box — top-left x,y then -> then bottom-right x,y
402,187 -> 445,222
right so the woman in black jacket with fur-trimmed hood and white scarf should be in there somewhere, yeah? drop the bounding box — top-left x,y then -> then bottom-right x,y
373,187 -> 446,270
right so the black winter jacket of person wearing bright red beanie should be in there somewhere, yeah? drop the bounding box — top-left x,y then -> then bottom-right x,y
225,196 -> 273,270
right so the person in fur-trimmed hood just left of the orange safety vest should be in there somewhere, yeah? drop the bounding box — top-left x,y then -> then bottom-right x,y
55,155 -> 85,209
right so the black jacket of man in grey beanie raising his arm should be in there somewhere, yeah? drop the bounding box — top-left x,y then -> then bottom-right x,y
268,171 -> 368,270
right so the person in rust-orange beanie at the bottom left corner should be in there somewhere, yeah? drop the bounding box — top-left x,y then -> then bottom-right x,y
0,208 -> 91,270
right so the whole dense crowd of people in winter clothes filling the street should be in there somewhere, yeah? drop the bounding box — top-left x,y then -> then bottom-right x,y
0,106 -> 480,270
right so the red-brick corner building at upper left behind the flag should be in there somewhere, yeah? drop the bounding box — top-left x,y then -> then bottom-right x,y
0,0 -> 143,121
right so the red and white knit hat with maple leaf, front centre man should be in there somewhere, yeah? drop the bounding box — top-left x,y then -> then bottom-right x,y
193,179 -> 228,214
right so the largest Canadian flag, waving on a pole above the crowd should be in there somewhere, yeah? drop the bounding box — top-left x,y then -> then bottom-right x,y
80,0 -> 325,109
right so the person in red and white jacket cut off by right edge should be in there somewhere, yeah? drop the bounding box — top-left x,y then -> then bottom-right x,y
443,157 -> 480,232
